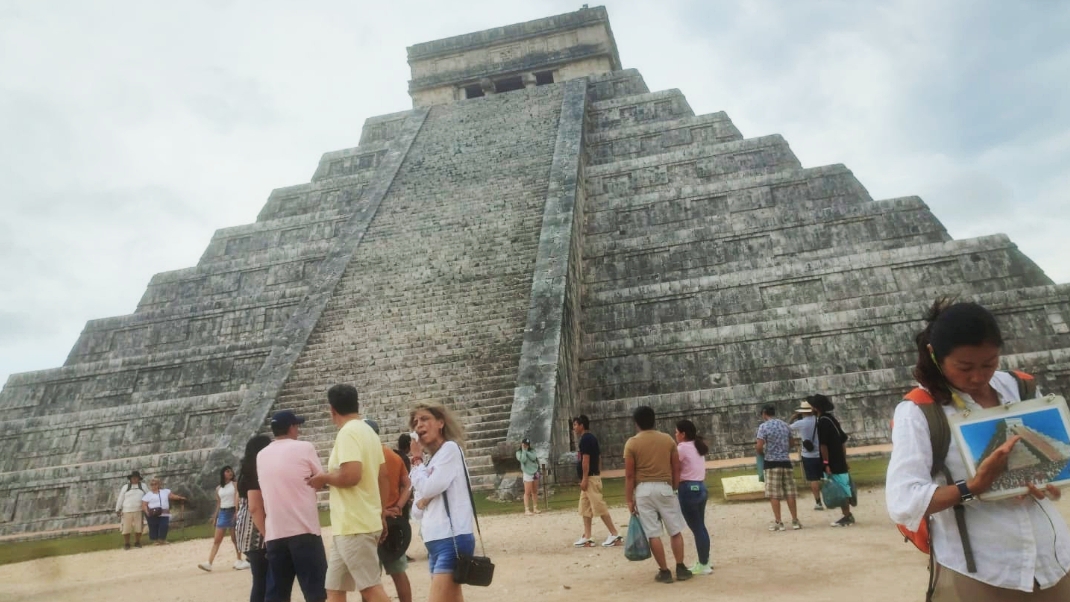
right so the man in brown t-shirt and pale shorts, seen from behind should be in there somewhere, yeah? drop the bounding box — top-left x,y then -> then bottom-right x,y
624,405 -> 691,583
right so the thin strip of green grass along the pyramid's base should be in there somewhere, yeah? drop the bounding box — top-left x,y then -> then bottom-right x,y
0,458 -> 888,565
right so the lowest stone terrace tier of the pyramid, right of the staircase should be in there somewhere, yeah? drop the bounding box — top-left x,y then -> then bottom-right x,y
581,348 -> 1070,468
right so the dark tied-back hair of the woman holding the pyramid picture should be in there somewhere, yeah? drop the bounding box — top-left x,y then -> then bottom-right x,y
914,297 -> 1003,404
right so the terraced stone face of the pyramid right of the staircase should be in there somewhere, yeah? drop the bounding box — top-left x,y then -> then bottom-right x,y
580,82 -> 1070,466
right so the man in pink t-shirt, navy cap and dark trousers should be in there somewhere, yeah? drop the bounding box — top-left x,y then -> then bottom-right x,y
257,411 -> 327,602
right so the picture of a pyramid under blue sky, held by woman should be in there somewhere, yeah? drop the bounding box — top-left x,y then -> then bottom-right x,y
949,396 -> 1070,499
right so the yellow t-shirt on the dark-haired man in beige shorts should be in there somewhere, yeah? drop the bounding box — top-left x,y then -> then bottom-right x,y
327,420 -> 383,535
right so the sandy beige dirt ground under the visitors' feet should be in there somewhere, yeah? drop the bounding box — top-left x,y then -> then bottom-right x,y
0,489 -> 1070,602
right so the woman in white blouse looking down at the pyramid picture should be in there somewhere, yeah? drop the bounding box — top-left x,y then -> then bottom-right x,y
885,299 -> 1070,602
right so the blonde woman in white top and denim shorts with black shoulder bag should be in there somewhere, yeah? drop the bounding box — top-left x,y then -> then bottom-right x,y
409,402 -> 475,602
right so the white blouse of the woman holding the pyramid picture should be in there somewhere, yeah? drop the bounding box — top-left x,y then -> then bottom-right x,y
885,372 -> 1070,591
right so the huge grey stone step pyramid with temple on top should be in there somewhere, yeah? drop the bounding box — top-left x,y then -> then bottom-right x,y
0,7 -> 1070,536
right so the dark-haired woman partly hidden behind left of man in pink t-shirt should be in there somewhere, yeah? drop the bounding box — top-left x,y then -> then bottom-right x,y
234,435 -> 271,602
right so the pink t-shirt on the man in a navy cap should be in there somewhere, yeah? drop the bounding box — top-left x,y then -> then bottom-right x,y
257,438 -> 323,541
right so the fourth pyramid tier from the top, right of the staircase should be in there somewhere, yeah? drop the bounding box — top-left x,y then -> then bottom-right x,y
584,135 -> 801,201
